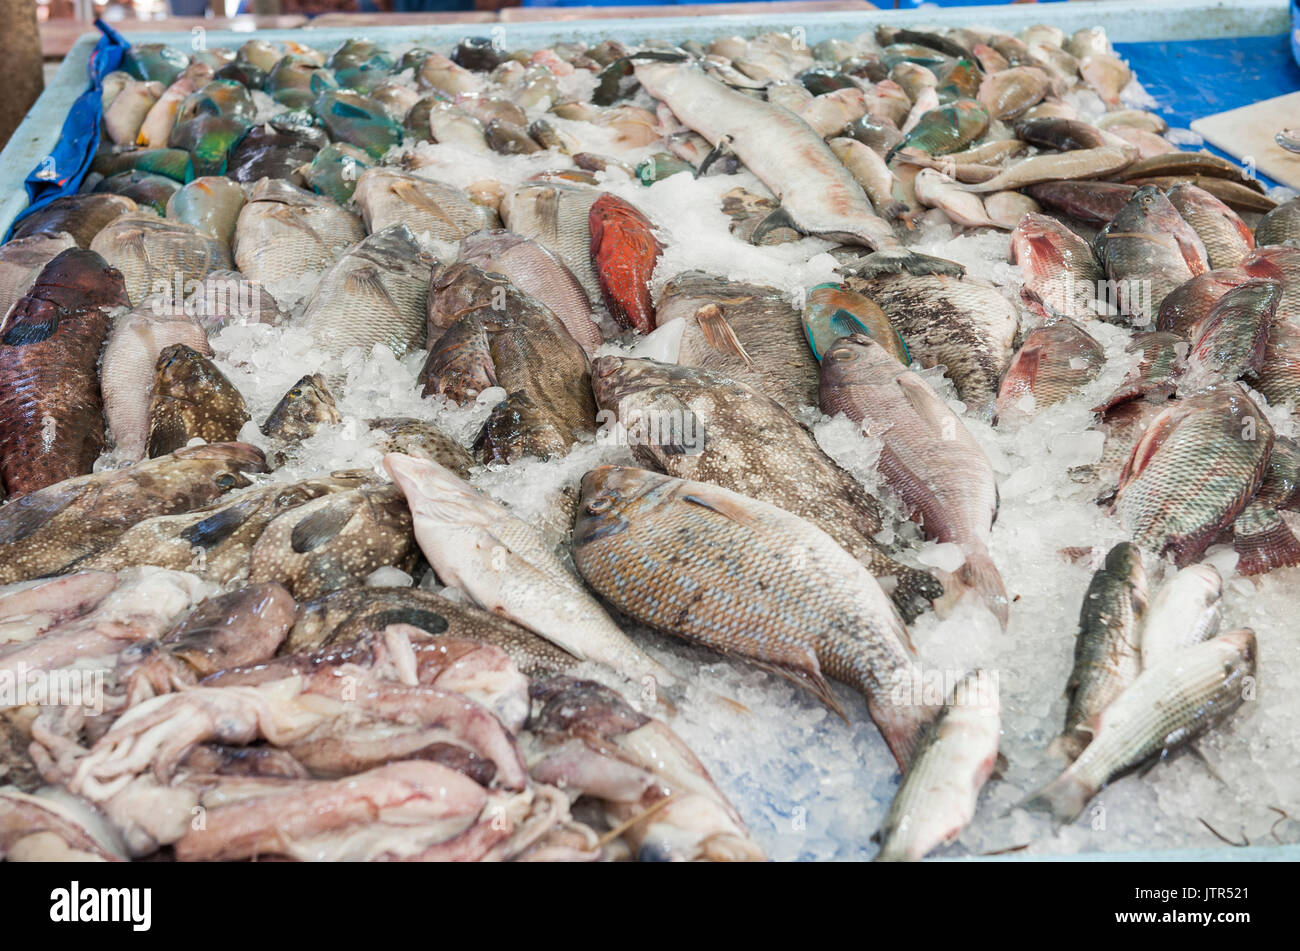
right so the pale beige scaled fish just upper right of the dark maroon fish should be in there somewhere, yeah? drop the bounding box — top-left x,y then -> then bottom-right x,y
90,212 -> 230,304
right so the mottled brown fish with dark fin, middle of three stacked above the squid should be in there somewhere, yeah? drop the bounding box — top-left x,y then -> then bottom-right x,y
73,478 -> 356,585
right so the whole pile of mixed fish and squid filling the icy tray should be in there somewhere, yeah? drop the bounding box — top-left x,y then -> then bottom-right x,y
0,26 -> 1300,860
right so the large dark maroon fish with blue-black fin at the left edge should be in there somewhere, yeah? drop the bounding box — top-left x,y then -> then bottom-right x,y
0,248 -> 130,499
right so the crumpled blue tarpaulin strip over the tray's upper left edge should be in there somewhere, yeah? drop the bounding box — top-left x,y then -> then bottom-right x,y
5,19 -> 130,239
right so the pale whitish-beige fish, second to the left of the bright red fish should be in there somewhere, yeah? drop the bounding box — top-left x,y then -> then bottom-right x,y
354,168 -> 499,242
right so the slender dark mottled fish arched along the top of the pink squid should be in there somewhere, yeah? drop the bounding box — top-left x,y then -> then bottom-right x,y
281,586 -> 580,677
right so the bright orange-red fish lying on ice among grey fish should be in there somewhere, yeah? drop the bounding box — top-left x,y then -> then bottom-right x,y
588,195 -> 663,334
